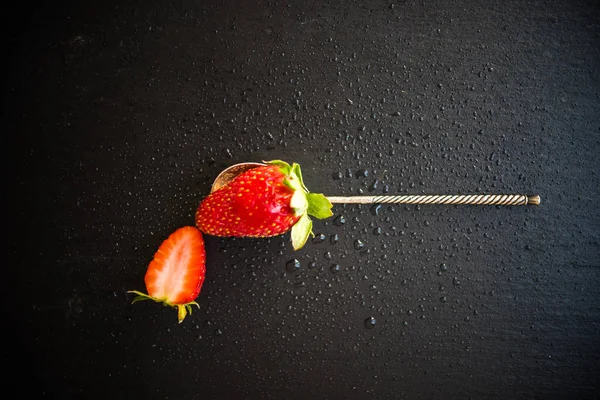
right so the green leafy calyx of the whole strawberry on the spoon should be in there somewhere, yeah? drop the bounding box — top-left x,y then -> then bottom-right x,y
264,160 -> 333,250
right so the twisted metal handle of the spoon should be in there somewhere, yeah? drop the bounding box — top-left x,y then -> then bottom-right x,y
327,194 -> 540,206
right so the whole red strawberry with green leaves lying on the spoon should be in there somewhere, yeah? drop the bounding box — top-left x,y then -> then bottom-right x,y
196,160 -> 332,250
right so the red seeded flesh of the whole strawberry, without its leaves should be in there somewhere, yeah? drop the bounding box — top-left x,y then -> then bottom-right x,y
196,165 -> 300,237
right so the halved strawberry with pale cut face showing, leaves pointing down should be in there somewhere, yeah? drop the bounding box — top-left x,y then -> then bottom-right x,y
128,226 -> 206,323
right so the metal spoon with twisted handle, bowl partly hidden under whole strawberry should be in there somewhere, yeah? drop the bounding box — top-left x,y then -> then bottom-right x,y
210,162 -> 540,206
